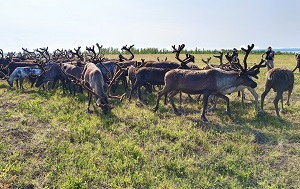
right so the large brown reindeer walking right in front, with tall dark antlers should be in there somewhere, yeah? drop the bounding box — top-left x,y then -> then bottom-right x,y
153,44 -> 261,122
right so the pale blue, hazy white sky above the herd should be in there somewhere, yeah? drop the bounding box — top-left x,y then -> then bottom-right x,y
0,0 -> 300,52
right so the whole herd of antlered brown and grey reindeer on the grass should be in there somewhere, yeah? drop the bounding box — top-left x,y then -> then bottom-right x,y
0,43 -> 300,121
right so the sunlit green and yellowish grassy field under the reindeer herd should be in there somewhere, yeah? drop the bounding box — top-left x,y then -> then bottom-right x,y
0,54 -> 300,188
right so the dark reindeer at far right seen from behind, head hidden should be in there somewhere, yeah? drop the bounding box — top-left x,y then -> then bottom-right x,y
261,68 -> 294,118
